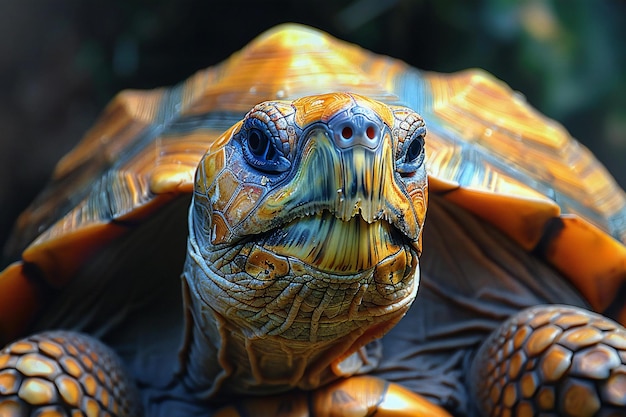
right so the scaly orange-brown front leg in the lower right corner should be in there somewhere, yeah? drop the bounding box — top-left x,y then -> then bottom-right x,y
470,305 -> 626,417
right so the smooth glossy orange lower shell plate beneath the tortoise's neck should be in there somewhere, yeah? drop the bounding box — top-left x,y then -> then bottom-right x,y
215,376 -> 450,417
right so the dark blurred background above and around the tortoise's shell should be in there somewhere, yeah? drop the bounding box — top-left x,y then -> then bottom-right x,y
0,0 -> 626,250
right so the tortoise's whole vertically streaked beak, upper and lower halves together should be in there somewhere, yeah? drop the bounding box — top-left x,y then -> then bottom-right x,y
250,125 -> 419,273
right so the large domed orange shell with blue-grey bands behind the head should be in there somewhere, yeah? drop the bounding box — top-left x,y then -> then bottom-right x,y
0,25 -> 626,416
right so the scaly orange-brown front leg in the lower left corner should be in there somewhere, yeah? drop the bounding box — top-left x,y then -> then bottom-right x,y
0,331 -> 140,417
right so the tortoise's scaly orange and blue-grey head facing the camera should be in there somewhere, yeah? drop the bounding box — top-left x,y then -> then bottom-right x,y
178,93 -> 427,394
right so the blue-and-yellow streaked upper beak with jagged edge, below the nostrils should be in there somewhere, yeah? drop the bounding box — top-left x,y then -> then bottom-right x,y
257,126 -> 421,241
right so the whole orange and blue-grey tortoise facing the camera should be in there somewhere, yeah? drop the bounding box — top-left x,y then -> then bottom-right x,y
0,24 -> 626,416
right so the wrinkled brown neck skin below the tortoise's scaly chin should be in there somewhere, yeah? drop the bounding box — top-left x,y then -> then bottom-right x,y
180,249 -> 378,401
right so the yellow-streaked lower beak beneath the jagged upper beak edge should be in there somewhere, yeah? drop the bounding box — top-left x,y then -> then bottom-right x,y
257,210 -> 417,275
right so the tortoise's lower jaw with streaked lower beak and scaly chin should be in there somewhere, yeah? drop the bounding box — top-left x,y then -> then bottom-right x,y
187,210 -> 419,342
